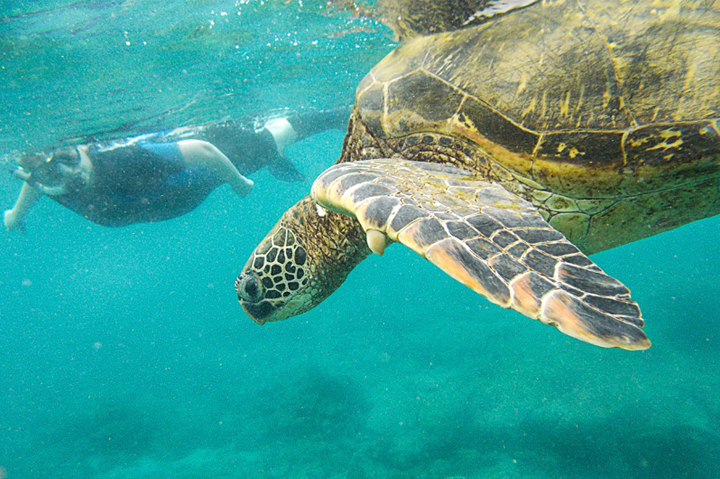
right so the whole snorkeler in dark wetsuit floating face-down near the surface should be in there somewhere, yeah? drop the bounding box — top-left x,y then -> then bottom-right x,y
4,108 -> 349,230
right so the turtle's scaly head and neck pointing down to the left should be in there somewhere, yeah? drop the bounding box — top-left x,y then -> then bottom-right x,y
235,197 -> 370,324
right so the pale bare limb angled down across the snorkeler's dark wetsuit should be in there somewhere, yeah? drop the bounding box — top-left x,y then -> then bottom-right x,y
177,140 -> 253,196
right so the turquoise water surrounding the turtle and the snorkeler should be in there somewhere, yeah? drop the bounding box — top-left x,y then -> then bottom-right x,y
0,0 -> 720,479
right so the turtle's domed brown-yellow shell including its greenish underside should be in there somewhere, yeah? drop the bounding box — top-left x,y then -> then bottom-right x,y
347,0 -> 720,252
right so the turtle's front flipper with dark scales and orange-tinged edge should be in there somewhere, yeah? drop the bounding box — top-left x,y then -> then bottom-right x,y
312,158 -> 650,350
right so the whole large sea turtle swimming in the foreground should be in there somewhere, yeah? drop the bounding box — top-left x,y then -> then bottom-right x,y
235,0 -> 720,350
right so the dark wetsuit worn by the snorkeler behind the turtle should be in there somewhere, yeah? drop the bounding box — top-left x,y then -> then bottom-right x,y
28,108 -> 350,226
